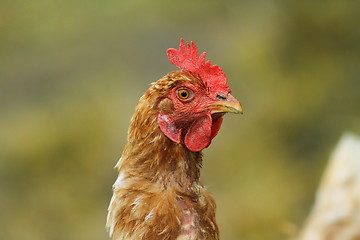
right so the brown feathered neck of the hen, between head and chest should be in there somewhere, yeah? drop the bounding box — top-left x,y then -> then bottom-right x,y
118,96 -> 202,192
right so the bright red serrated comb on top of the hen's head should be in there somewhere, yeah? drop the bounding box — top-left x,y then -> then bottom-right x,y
166,39 -> 228,92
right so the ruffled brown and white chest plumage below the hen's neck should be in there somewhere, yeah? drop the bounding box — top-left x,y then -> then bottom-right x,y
107,172 -> 218,240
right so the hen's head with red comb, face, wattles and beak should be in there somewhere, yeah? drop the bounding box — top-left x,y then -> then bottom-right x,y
152,39 -> 242,152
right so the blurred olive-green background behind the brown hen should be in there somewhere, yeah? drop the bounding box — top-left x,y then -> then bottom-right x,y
0,0 -> 360,240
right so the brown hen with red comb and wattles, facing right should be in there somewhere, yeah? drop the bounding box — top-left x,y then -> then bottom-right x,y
106,39 -> 242,240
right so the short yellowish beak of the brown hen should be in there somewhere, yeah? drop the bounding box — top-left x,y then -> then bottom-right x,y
204,94 -> 243,114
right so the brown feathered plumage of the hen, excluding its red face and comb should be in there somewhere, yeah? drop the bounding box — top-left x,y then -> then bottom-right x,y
107,71 -> 219,240
